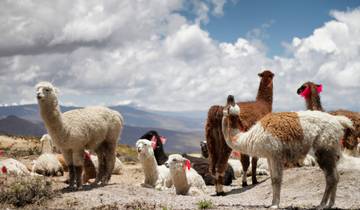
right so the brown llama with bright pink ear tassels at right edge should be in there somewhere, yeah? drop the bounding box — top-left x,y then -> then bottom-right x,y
297,82 -> 360,151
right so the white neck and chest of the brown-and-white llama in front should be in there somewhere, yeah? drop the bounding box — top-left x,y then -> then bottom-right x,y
222,117 -> 256,156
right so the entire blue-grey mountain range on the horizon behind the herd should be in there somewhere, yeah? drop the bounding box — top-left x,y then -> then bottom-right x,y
0,104 -> 206,153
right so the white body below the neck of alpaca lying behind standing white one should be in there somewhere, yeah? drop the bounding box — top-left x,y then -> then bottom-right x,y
31,153 -> 64,176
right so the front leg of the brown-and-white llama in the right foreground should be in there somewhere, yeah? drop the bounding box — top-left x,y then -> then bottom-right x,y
268,159 -> 283,208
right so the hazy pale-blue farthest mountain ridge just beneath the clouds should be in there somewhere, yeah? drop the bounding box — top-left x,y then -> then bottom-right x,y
0,104 -> 205,132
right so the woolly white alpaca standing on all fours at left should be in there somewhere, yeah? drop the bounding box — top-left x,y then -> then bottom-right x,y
36,82 -> 124,189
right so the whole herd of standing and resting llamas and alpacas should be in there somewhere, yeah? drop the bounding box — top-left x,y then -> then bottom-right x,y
0,70 -> 360,208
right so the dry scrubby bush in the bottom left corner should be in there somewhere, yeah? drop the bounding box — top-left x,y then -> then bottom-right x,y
0,176 -> 55,207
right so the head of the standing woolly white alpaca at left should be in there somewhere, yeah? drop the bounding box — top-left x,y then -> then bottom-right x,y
35,82 -> 58,106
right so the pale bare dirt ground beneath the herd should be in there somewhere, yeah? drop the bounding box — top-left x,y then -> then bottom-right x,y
0,135 -> 360,209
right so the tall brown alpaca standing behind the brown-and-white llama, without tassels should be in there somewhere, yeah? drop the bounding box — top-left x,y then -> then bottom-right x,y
205,70 -> 274,195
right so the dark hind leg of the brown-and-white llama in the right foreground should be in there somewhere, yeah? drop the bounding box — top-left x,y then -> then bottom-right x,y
315,149 -> 339,208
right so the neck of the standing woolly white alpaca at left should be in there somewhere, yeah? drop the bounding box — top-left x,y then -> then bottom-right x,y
40,104 -> 66,141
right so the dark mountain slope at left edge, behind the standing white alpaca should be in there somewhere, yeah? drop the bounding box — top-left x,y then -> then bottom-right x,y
0,115 -> 46,136
